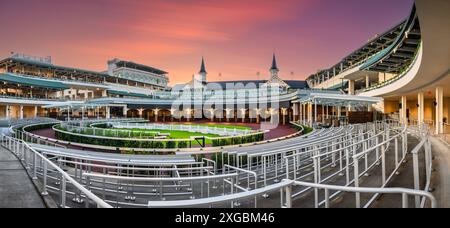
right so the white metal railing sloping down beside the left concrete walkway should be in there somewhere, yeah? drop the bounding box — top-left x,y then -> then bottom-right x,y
0,135 -> 111,208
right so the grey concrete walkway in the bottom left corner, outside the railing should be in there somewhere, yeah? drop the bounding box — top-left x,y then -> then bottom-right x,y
0,147 -> 46,208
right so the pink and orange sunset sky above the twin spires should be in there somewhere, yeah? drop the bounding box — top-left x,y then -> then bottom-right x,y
0,0 -> 413,85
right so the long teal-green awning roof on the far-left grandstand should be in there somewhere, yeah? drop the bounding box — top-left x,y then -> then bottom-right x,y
0,73 -> 70,90
